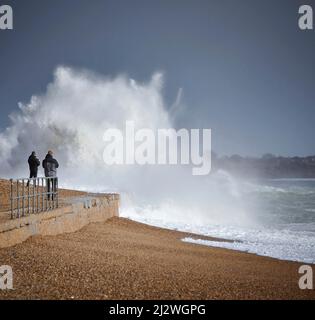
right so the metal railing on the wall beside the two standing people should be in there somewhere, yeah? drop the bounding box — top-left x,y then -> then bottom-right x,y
10,177 -> 59,219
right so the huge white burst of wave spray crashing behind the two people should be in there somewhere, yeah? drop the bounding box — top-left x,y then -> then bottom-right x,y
0,67 -> 314,261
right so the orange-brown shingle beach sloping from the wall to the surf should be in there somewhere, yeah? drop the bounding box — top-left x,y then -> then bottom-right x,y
0,218 -> 315,299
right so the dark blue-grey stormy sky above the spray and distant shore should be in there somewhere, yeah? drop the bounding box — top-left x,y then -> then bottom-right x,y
0,0 -> 315,156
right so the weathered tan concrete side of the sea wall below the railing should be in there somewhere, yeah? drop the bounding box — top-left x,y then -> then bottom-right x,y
0,194 -> 120,248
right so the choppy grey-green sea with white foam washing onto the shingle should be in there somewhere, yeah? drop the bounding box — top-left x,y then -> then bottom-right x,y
121,179 -> 315,263
